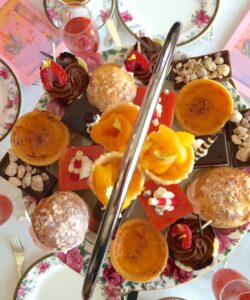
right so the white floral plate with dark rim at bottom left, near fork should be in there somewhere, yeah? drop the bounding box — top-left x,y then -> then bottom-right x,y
13,248 -> 103,300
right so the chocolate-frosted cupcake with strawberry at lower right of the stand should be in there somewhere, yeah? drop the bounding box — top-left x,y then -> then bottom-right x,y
167,219 -> 218,270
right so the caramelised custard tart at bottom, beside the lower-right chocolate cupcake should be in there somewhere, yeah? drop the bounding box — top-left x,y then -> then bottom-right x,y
110,219 -> 168,282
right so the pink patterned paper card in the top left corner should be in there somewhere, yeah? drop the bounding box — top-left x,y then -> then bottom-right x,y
0,0 -> 65,85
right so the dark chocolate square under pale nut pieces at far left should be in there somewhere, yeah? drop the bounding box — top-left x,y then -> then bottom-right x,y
0,153 -> 57,199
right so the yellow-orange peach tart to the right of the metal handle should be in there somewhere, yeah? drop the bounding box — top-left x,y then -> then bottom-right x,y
140,125 -> 194,184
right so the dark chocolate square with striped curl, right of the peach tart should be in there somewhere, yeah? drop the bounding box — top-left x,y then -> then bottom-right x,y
194,132 -> 230,168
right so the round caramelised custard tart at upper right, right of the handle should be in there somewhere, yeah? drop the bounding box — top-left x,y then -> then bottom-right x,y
175,79 -> 233,136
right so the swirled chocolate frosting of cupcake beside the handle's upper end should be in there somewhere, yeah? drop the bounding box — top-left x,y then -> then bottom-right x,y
134,37 -> 162,85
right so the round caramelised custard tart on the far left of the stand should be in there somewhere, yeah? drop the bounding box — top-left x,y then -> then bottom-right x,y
11,110 -> 70,166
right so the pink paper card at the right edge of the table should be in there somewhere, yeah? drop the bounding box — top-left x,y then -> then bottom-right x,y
224,11 -> 250,97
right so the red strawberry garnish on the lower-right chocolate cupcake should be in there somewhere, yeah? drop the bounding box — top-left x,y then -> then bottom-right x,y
170,223 -> 192,250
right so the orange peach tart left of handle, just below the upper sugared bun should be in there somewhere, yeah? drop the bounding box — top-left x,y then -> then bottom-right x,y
90,103 -> 140,152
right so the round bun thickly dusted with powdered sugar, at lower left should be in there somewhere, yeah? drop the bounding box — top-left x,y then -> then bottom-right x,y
32,192 -> 89,252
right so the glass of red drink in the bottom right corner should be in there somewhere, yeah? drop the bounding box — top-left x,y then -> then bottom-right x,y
212,268 -> 250,300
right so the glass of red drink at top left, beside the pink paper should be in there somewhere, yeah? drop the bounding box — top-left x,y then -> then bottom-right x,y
58,2 -> 99,60
